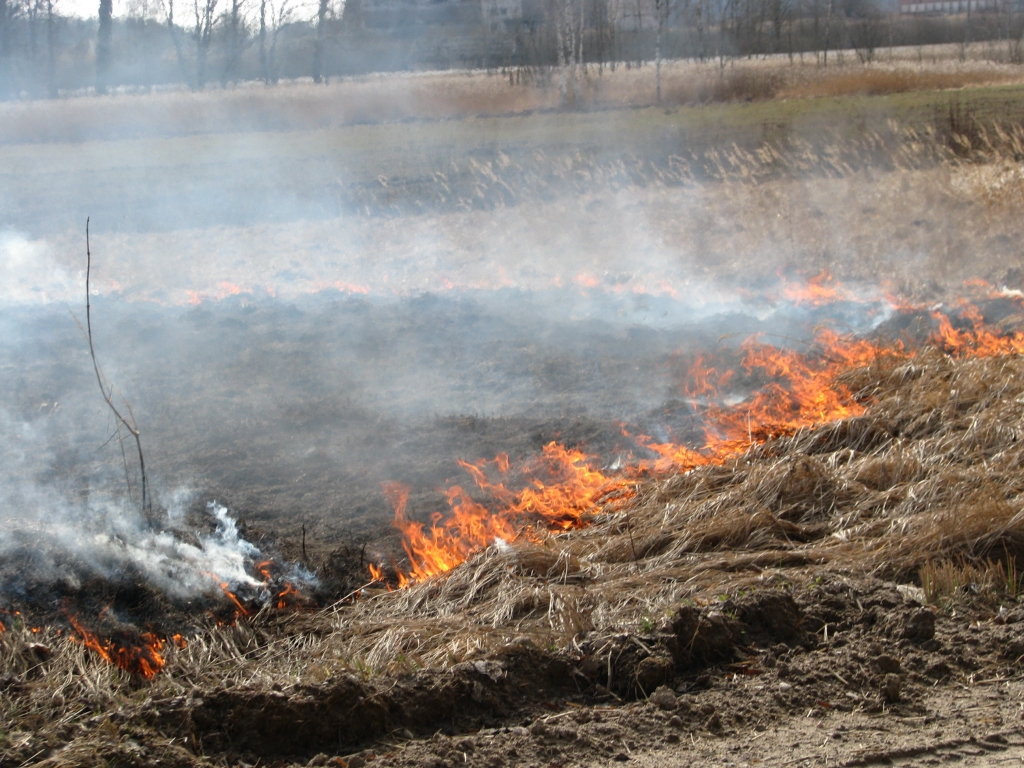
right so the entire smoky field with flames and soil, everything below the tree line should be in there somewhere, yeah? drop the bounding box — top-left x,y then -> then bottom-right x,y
0,49 -> 1024,768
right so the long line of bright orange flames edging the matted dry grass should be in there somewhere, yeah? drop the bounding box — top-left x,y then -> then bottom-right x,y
371,271 -> 1024,587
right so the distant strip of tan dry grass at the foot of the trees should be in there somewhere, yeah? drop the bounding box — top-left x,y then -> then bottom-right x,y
0,50 -> 1024,143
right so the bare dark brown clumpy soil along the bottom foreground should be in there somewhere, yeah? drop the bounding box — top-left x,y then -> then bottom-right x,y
14,577 -> 1024,768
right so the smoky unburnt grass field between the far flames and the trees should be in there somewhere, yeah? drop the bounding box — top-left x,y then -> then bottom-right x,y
0,51 -> 1024,301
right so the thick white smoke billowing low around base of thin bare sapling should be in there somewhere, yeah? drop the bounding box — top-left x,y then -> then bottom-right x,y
0,434 -> 315,602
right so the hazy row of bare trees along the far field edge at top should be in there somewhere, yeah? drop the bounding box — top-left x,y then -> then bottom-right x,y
0,0 -> 1024,100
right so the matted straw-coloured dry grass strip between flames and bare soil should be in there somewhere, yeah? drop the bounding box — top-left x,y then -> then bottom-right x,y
6,349 -> 1024,765
